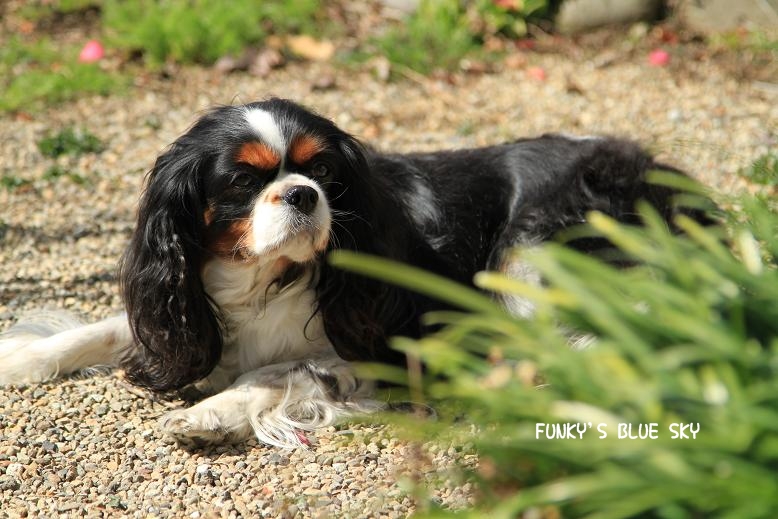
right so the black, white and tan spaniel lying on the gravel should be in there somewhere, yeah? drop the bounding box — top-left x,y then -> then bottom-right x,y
0,99 -> 704,447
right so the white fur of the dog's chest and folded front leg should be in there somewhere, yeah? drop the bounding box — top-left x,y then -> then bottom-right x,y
160,260 -> 376,447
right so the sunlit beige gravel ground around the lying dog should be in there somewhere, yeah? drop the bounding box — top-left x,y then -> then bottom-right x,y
0,43 -> 778,517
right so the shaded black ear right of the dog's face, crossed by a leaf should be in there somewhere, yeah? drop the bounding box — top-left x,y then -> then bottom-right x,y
317,134 -> 420,363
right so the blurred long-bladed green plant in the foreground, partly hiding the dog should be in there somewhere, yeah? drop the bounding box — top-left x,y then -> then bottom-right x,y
332,189 -> 778,519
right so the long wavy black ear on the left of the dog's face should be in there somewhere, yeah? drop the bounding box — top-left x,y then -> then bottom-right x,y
119,136 -> 222,391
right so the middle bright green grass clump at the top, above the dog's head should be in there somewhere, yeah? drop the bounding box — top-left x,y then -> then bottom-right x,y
102,0 -> 320,66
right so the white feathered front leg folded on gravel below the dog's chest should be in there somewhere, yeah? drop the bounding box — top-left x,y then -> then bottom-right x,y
160,353 -> 379,448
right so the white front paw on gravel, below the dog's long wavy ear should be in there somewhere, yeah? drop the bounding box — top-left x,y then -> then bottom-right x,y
159,406 -> 230,447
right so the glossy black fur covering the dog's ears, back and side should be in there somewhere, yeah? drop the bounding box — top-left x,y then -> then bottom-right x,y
121,99 -> 704,390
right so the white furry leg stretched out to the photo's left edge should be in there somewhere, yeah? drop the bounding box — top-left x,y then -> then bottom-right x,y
0,312 -> 132,385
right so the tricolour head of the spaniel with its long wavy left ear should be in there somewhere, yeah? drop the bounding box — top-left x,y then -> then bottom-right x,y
120,99 -> 386,390
